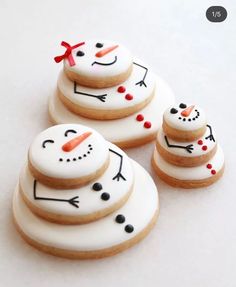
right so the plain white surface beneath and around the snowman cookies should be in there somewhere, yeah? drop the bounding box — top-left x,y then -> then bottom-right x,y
0,0 -> 236,287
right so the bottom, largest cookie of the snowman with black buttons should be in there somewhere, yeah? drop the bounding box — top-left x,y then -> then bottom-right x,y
13,161 -> 159,259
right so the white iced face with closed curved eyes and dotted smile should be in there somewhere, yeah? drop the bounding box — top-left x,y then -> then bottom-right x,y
29,124 -> 109,179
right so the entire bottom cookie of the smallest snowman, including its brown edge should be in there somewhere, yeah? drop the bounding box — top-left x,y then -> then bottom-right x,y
152,145 -> 224,188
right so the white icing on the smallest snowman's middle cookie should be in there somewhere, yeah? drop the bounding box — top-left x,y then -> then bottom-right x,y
157,128 -> 217,157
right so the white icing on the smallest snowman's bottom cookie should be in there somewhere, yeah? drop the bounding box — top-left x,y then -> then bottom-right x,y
154,145 -> 224,180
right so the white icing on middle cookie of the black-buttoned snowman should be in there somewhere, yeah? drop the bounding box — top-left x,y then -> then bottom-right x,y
20,143 -> 134,216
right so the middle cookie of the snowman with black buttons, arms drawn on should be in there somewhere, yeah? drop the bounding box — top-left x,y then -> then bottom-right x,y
19,143 -> 134,224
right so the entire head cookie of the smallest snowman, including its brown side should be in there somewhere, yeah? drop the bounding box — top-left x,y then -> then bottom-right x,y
163,103 -> 207,141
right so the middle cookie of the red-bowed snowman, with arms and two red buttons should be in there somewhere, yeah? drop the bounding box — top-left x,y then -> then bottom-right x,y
57,60 -> 158,120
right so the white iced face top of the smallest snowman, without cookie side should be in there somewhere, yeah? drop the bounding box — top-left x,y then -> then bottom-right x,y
164,103 -> 206,131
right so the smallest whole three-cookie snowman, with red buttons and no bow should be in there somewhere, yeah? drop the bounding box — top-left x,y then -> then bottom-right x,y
152,103 -> 224,188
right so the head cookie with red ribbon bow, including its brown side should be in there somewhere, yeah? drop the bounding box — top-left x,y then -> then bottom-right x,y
54,40 -> 133,88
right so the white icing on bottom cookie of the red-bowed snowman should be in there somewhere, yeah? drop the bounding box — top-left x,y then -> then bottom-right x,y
49,77 -> 174,143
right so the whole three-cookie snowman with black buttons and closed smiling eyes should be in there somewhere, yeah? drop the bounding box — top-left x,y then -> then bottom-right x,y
13,124 -> 159,259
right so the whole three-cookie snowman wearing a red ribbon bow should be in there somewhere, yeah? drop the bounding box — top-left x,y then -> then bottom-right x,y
49,40 -> 174,147
